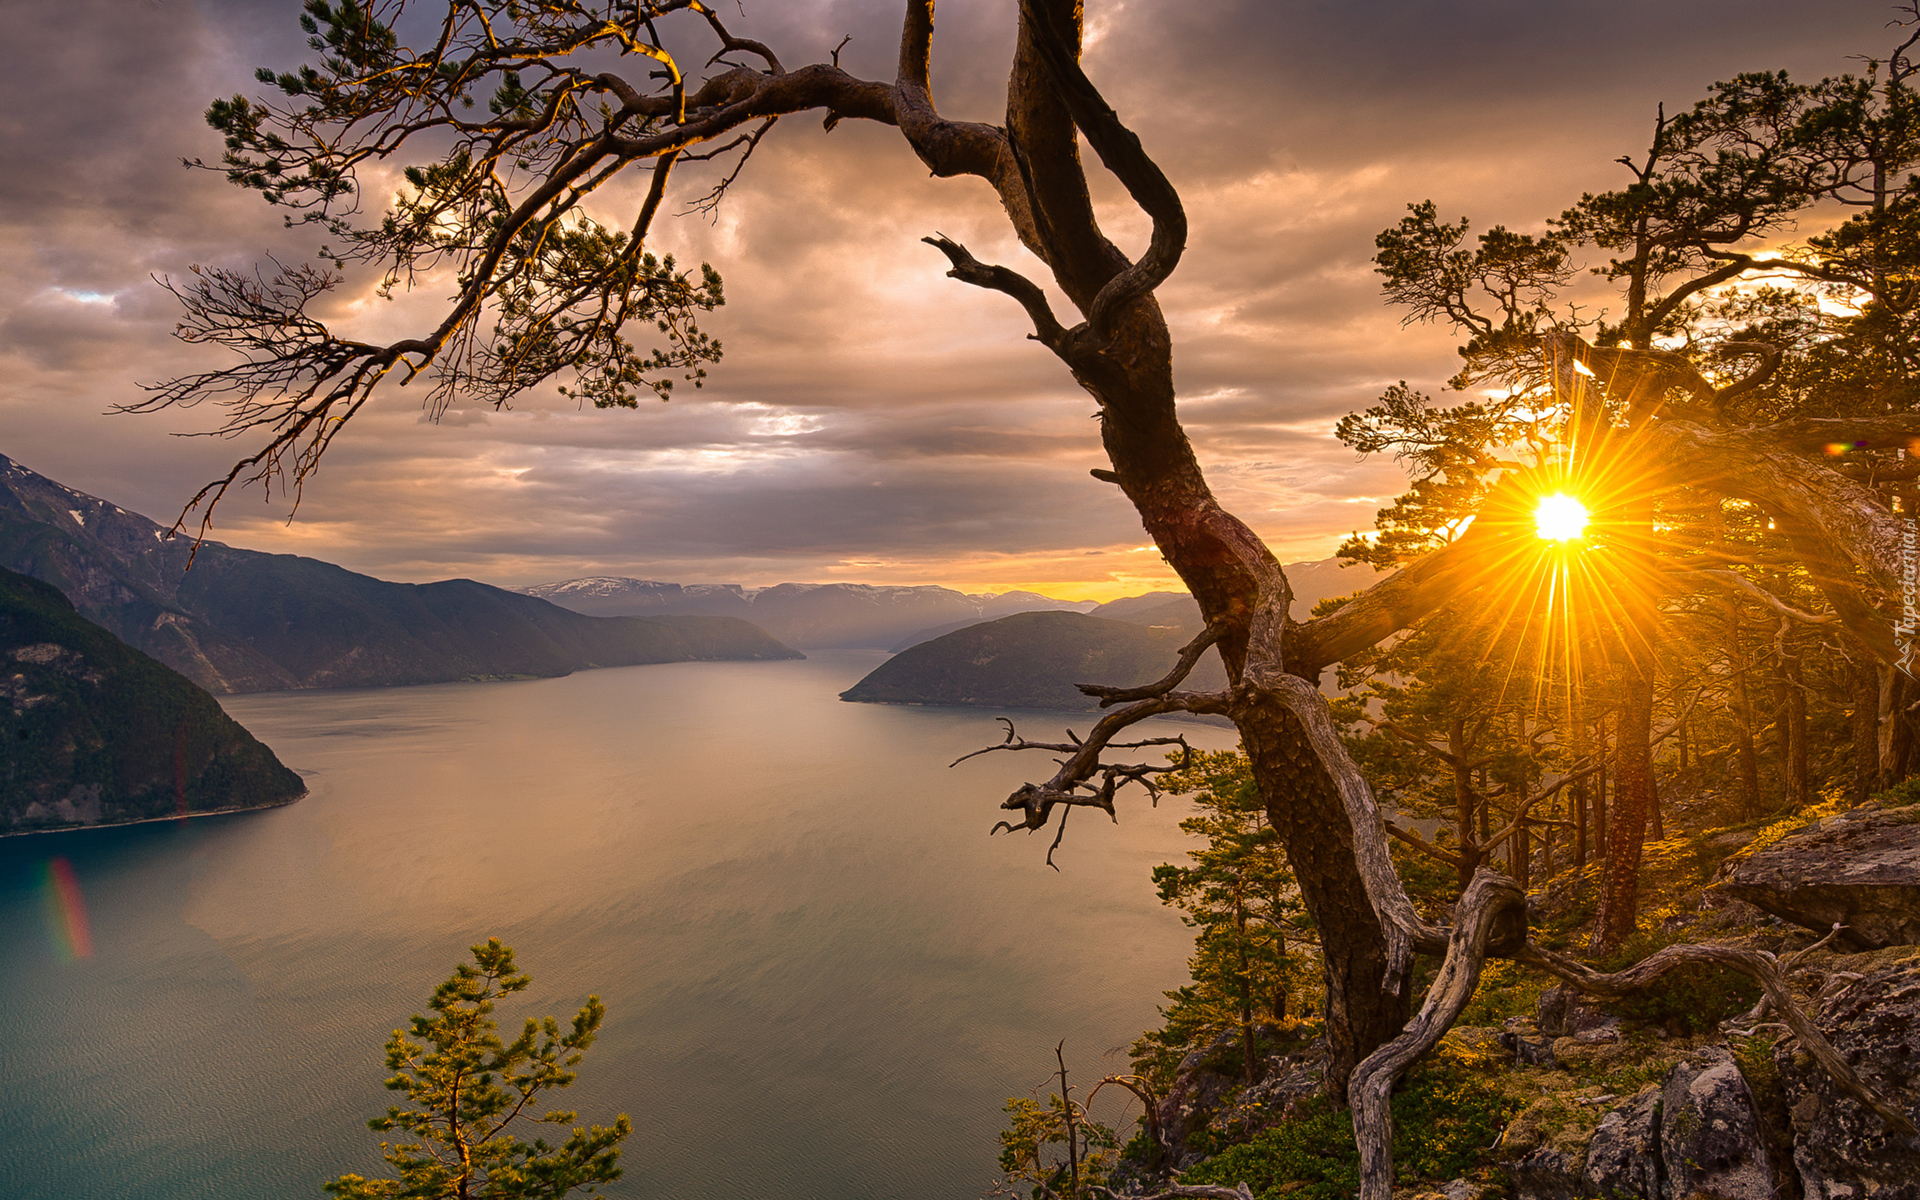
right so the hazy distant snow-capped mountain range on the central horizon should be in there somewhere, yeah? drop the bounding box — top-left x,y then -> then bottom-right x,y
520,576 -> 1092,649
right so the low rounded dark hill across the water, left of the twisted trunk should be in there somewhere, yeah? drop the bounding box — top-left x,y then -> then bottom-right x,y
841,612 -> 1187,712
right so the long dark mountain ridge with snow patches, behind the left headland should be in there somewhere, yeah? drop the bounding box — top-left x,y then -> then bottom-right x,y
0,455 -> 797,691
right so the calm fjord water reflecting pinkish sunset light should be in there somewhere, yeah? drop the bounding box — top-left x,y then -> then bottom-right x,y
0,653 -> 1233,1200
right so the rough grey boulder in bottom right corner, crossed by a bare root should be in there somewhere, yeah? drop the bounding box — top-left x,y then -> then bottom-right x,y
1774,952 -> 1920,1200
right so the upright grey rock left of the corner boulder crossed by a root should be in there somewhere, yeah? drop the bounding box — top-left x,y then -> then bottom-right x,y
1661,1046 -> 1774,1200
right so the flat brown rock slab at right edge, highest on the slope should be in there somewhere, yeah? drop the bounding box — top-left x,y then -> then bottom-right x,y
1718,810 -> 1920,948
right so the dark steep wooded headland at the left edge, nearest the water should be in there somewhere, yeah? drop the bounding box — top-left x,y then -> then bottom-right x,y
0,568 -> 307,833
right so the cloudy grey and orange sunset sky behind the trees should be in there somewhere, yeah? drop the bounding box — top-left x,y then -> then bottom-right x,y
0,0 -> 1893,599
